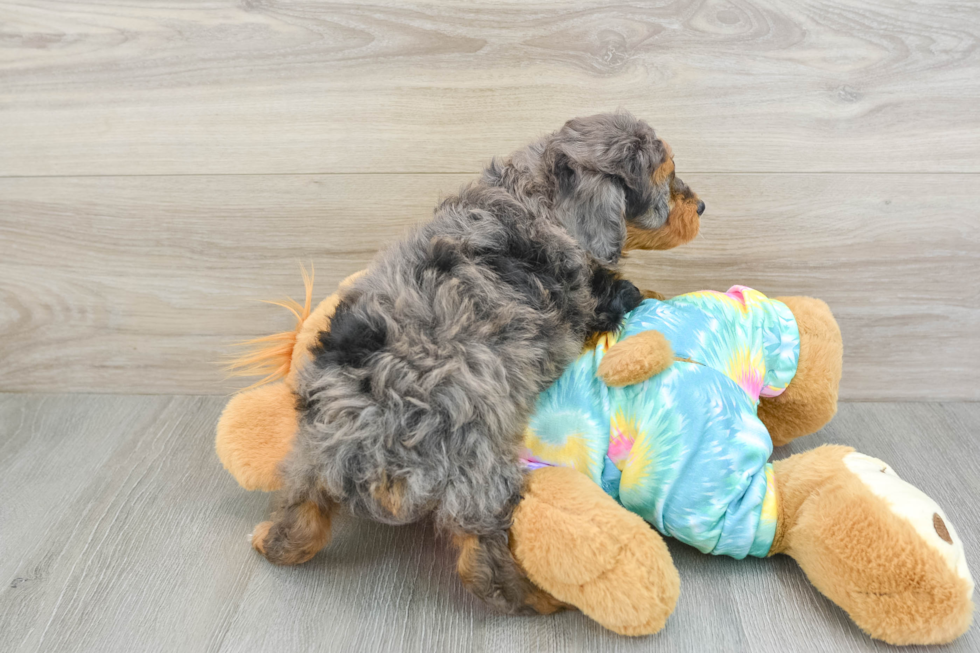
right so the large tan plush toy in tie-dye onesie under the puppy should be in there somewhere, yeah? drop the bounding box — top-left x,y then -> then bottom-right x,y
216,268 -> 973,644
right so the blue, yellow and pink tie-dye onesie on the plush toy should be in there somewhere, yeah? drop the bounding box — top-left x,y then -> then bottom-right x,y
524,286 -> 800,558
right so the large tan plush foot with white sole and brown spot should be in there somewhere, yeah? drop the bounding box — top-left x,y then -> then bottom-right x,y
770,445 -> 973,645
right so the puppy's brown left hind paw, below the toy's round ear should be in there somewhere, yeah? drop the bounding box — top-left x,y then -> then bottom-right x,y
252,491 -> 336,565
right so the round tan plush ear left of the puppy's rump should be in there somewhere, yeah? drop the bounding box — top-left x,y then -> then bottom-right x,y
214,382 -> 299,492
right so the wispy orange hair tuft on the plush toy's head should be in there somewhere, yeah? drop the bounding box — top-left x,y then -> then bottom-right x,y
225,266 -> 314,392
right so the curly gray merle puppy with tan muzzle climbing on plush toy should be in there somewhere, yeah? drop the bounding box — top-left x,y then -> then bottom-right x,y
253,113 -> 704,612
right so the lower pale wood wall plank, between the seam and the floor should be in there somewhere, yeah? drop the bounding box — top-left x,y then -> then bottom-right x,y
0,174 -> 980,400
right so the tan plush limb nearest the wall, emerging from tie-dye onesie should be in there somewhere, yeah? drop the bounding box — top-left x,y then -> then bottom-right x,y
759,297 -> 844,447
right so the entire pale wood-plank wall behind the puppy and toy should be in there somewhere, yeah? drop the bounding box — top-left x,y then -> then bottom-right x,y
0,0 -> 980,400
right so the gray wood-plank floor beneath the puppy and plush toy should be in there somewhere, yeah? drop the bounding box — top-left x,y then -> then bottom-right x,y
0,394 -> 980,653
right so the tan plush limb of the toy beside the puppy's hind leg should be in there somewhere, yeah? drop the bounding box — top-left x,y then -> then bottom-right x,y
510,467 -> 680,635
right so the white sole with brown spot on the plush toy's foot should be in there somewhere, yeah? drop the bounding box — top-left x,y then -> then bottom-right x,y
844,451 -> 974,598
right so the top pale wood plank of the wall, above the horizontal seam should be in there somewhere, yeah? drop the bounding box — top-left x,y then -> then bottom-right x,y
0,0 -> 980,176
